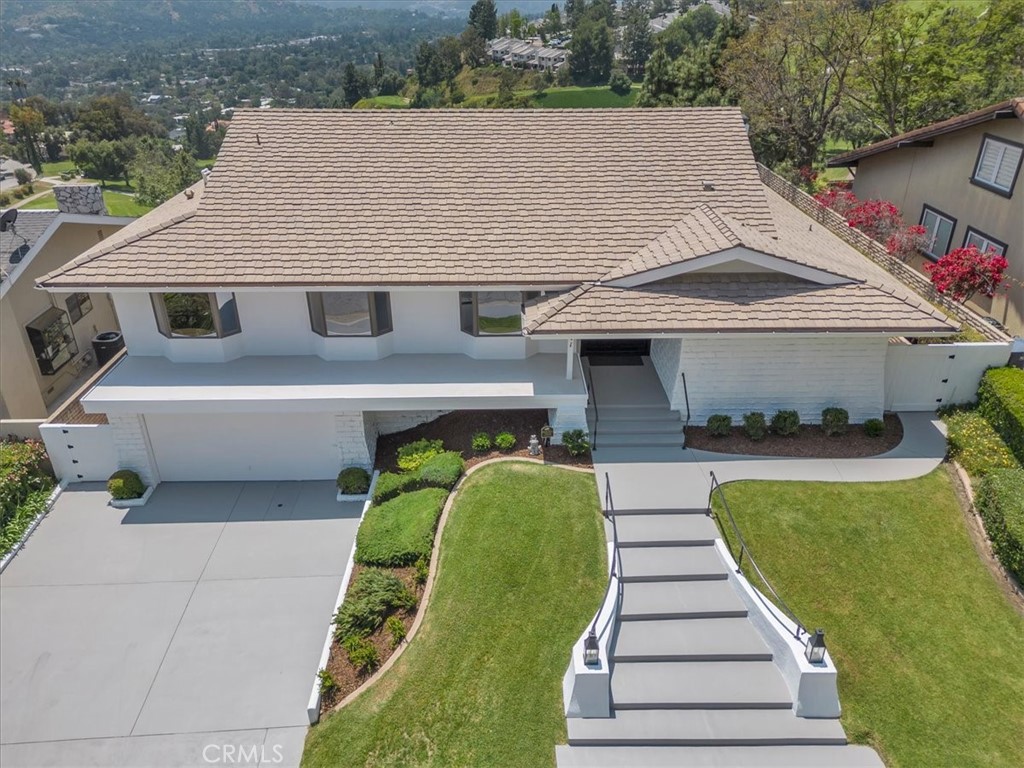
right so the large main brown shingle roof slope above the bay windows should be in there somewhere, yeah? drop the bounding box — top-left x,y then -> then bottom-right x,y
43,108 -> 773,289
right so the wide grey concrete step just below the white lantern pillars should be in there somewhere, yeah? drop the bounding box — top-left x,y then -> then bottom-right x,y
566,710 -> 846,746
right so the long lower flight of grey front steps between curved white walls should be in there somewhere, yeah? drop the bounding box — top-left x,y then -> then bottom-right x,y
555,501 -> 882,768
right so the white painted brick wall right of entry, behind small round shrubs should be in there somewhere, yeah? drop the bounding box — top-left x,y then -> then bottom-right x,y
651,335 -> 888,425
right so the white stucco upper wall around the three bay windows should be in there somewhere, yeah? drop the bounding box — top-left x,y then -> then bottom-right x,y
114,291 -> 552,362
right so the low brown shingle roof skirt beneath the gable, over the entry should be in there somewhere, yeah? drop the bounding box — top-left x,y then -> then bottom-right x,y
526,274 -> 956,335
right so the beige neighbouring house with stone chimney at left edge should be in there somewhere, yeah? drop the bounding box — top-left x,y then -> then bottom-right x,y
0,185 -> 134,420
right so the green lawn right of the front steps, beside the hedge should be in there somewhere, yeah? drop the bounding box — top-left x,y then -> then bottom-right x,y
712,468 -> 1024,768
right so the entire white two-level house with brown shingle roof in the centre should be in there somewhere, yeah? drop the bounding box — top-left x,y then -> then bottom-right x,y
39,108 -> 974,482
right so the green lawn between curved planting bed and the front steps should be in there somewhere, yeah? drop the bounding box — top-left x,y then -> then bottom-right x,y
303,462 -> 605,768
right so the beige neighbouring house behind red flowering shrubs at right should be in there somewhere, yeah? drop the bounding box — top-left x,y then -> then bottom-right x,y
828,97 -> 1024,336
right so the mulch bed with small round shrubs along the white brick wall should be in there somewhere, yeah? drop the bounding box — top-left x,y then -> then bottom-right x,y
686,414 -> 903,459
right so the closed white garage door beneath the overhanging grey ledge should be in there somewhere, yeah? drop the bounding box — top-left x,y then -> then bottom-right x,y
145,414 -> 341,481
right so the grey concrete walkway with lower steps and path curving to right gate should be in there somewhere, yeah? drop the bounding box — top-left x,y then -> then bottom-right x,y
556,414 -> 946,768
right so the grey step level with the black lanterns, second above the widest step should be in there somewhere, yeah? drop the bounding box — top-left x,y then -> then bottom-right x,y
611,617 -> 772,663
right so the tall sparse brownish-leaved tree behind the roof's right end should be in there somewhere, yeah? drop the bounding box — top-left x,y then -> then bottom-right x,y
723,0 -> 876,167
